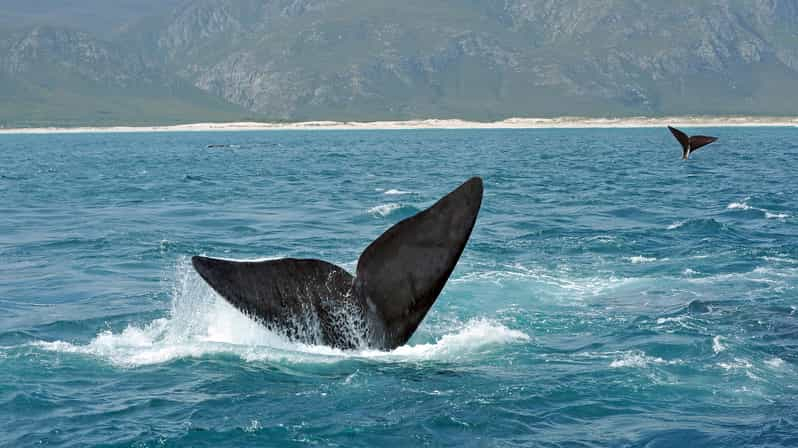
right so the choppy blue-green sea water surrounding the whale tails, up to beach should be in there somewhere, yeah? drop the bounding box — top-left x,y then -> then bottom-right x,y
0,128 -> 798,447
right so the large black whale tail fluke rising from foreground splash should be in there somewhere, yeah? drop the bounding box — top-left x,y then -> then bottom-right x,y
191,177 -> 482,350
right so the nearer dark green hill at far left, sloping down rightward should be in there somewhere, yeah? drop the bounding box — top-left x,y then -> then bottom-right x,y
0,26 -> 251,126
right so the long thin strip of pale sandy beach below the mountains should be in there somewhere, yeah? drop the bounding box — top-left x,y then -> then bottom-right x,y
0,116 -> 798,134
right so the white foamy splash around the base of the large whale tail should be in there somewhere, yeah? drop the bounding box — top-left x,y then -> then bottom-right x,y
32,260 -> 529,368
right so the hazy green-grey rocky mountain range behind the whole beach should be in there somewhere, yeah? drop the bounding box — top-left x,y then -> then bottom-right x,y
0,0 -> 798,126
